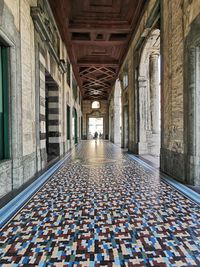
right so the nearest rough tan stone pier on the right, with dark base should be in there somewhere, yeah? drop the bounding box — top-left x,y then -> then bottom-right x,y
161,0 -> 200,184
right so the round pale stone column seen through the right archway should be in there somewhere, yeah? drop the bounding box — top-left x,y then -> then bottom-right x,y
150,53 -> 160,133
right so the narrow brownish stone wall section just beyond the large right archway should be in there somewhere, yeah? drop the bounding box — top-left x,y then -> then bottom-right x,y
119,0 -> 157,153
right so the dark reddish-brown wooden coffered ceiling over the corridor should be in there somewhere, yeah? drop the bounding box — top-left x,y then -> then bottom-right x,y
49,0 -> 147,100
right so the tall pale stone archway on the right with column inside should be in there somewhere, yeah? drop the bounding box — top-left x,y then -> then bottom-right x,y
138,29 -> 160,156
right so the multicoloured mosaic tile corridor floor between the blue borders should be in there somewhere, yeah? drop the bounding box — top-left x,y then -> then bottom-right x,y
0,140 -> 200,267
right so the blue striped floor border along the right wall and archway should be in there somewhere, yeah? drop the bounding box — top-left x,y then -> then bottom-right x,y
128,154 -> 200,205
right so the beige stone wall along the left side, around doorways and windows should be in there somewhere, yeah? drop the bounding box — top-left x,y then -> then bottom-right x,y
0,0 -> 82,198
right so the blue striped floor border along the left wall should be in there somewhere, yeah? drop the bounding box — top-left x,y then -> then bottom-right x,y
0,150 -> 72,229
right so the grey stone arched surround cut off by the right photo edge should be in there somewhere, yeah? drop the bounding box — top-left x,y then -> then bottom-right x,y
184,15 -> 200,186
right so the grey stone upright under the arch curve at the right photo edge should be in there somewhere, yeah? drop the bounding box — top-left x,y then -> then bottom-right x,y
187,46 -> 200,186
